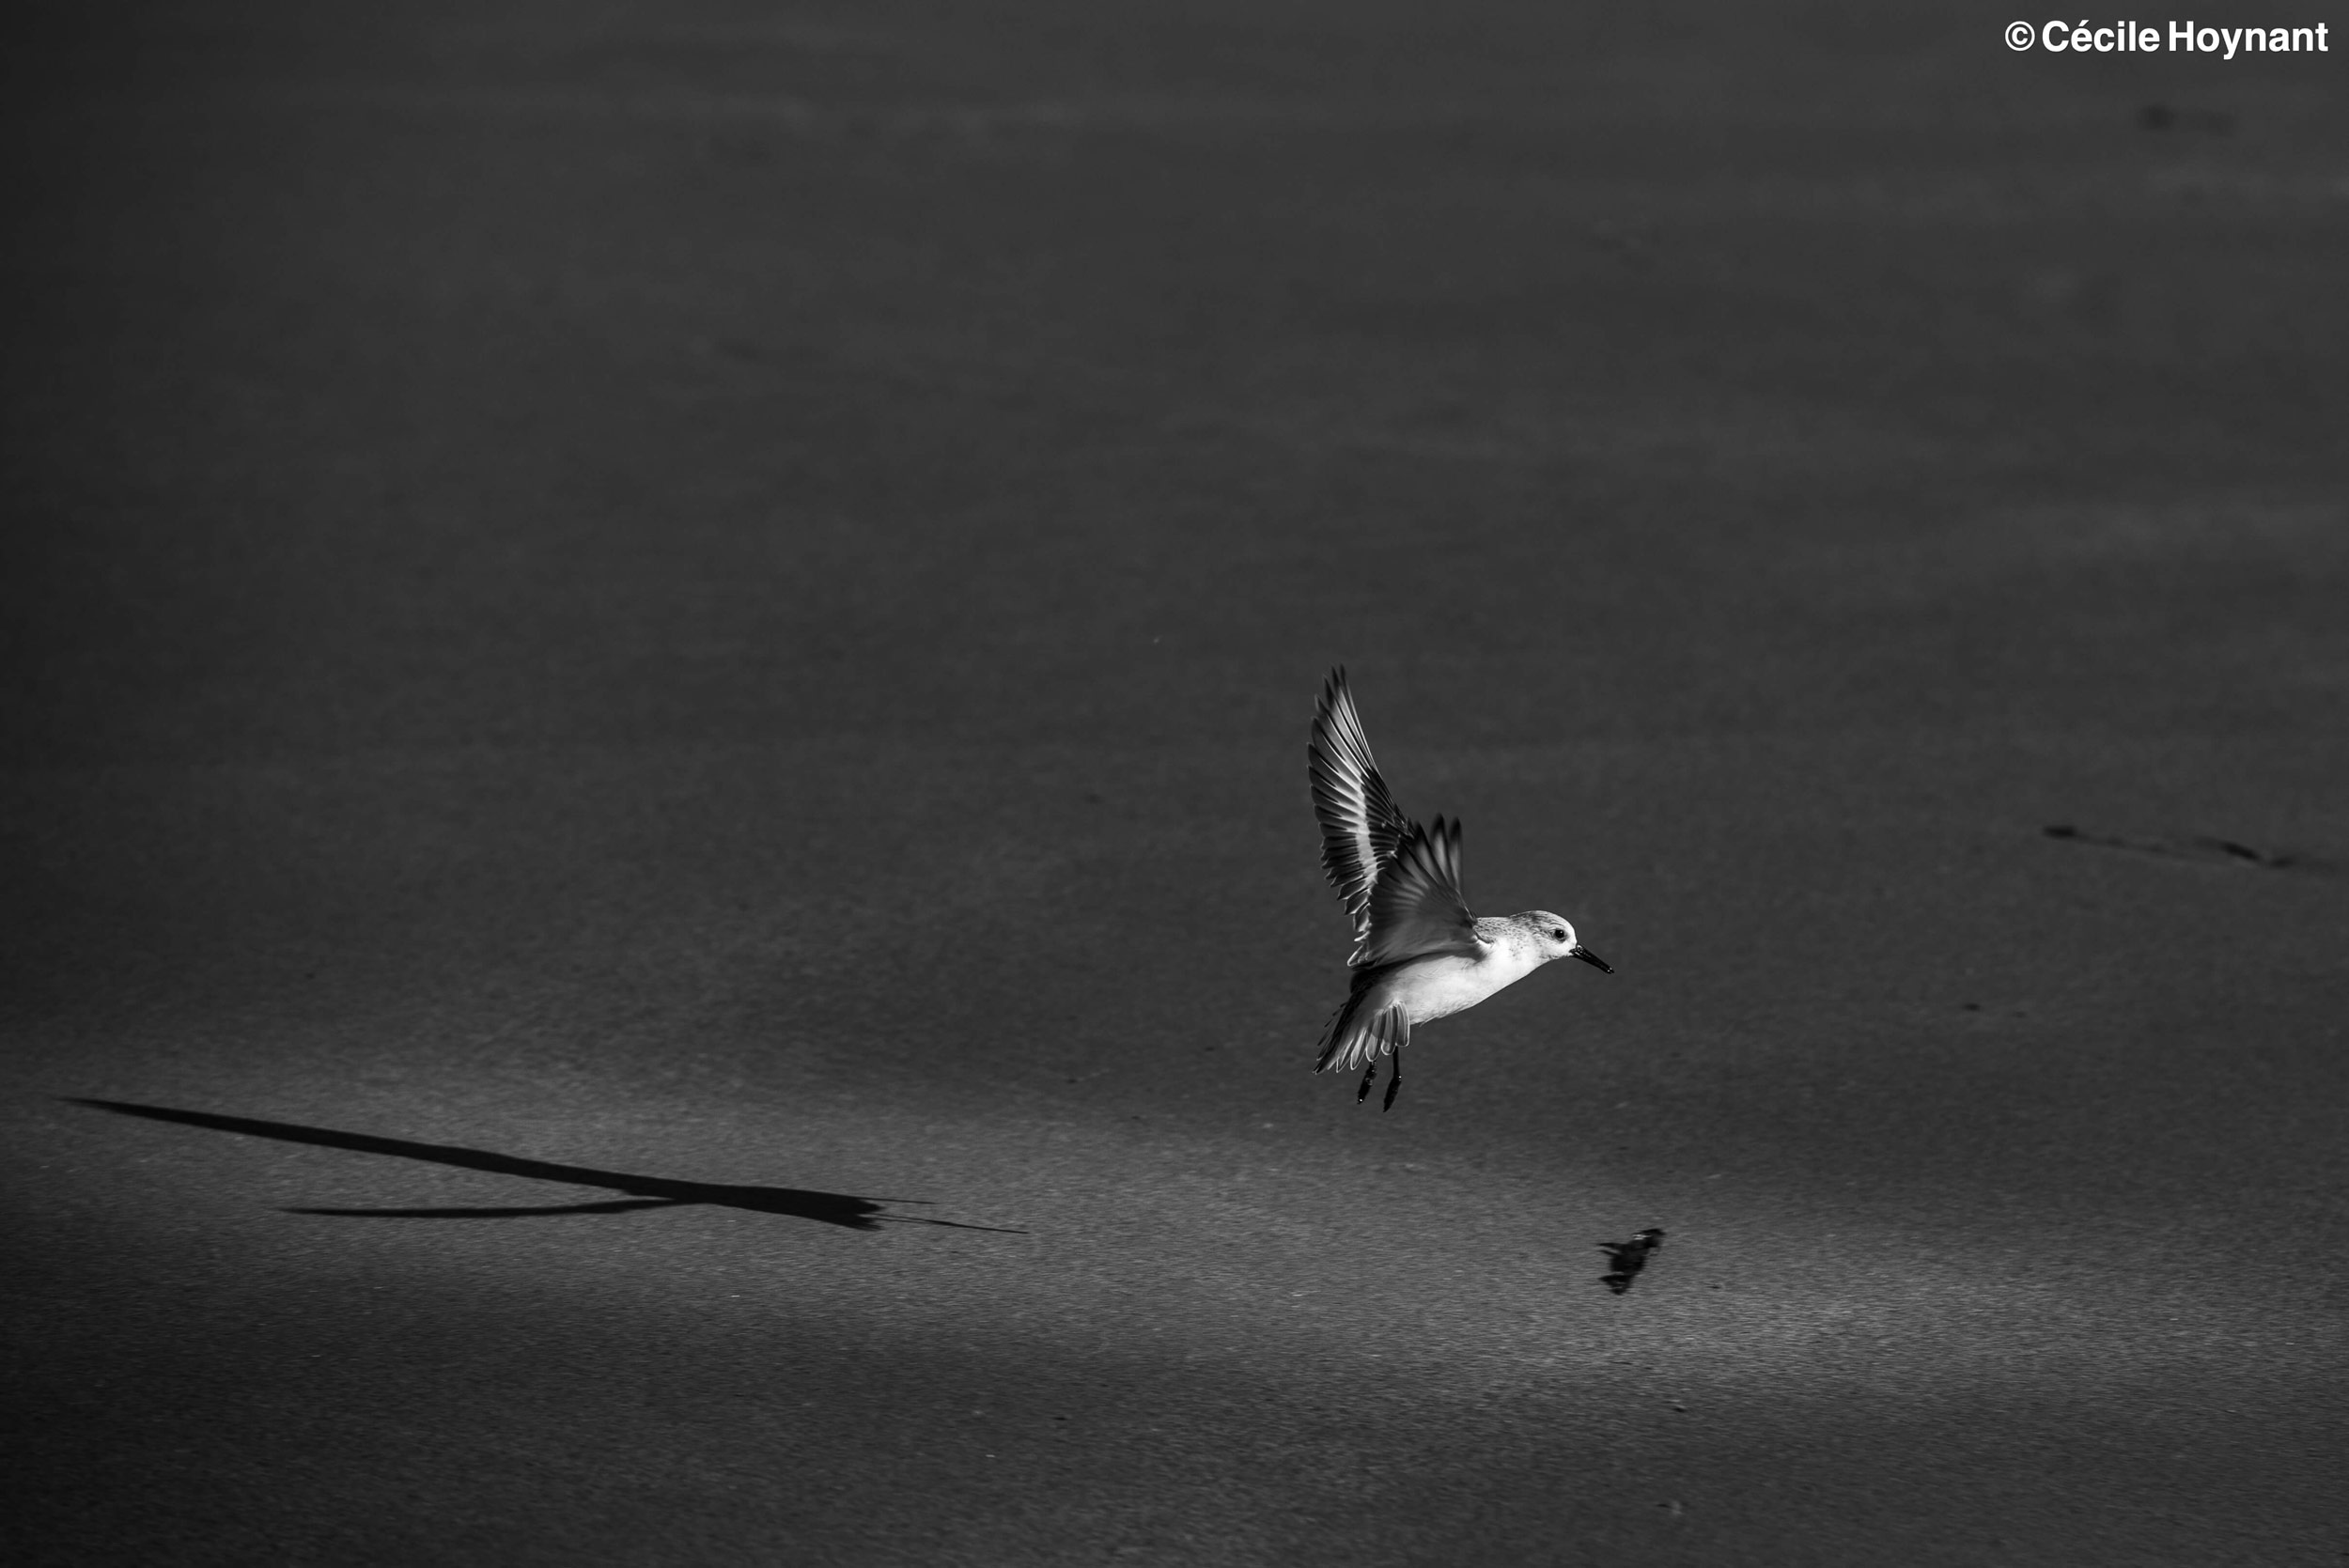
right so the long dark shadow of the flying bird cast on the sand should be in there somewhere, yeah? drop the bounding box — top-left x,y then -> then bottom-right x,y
69,1098 -> 1027,1234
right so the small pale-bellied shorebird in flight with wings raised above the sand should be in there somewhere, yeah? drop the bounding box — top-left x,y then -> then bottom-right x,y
1306,667 -> 1614,1110
